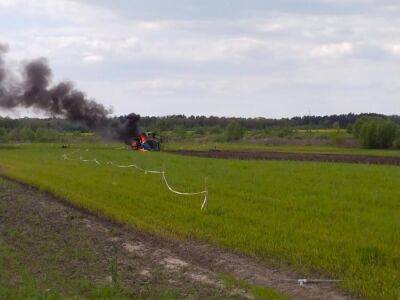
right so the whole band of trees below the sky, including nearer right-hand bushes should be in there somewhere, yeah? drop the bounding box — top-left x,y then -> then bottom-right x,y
0,113 -> 400,148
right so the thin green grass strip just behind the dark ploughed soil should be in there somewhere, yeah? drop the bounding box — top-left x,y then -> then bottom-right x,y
165,142 -> 400,156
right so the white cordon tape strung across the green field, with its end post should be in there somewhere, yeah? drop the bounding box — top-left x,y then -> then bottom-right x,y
62,150 -> 208,210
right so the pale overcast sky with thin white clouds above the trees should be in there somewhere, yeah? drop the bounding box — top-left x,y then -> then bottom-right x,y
0,0 -> 400,117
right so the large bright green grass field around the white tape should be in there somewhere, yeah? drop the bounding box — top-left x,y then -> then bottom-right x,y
0,145 -> 400,299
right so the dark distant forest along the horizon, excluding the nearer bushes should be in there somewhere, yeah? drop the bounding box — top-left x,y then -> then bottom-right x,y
0,113 -> 400,132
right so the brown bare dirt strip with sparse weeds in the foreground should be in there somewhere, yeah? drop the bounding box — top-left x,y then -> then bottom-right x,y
0,178 -> 349,299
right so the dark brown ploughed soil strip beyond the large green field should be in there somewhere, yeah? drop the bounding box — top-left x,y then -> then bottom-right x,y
168,150 -> 400,166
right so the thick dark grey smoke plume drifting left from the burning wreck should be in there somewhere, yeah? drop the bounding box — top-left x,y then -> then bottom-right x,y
0,43 -> 140,140
